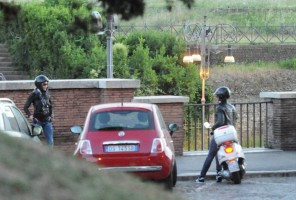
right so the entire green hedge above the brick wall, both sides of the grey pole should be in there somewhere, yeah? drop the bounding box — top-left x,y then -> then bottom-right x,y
0,0 -> 212,103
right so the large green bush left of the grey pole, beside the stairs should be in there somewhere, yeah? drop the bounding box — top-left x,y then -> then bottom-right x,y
1,0 -> 105,78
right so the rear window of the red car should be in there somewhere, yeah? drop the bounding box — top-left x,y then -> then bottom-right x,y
90,110 -> 154,131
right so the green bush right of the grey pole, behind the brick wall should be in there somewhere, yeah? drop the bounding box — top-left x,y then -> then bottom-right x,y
115,31 -> 212,103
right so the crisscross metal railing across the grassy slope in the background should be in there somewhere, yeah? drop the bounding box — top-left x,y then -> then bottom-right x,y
114,23 -> 296,45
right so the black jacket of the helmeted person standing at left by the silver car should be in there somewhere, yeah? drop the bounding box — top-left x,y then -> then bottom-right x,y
24,88 -> 52,122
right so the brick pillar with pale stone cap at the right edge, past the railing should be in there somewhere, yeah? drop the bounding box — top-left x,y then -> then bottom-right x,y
260,92 -> 296,150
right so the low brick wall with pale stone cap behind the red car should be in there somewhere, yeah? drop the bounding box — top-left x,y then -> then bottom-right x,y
0,79 -> 189,155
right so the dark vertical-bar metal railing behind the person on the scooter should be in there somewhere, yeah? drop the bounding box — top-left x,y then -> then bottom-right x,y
183,101 -> 272,151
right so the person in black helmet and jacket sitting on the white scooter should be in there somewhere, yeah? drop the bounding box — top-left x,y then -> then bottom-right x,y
195,86 -> 237,183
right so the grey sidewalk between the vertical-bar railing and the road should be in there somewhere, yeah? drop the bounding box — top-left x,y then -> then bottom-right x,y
176,148 -> 296,180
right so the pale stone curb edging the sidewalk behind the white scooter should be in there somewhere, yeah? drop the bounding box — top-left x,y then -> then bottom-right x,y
177,170 -> 296,181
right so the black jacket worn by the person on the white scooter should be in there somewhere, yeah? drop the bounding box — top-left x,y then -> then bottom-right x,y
212,102 -> 237,131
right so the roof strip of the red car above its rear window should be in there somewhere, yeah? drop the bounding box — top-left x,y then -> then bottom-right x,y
92,102 -> 156,111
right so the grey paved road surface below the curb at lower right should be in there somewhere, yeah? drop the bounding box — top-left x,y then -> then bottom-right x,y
173,176 -> 296,200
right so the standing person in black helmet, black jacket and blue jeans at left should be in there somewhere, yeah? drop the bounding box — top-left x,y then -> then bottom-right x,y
24,75 -> 53,147
